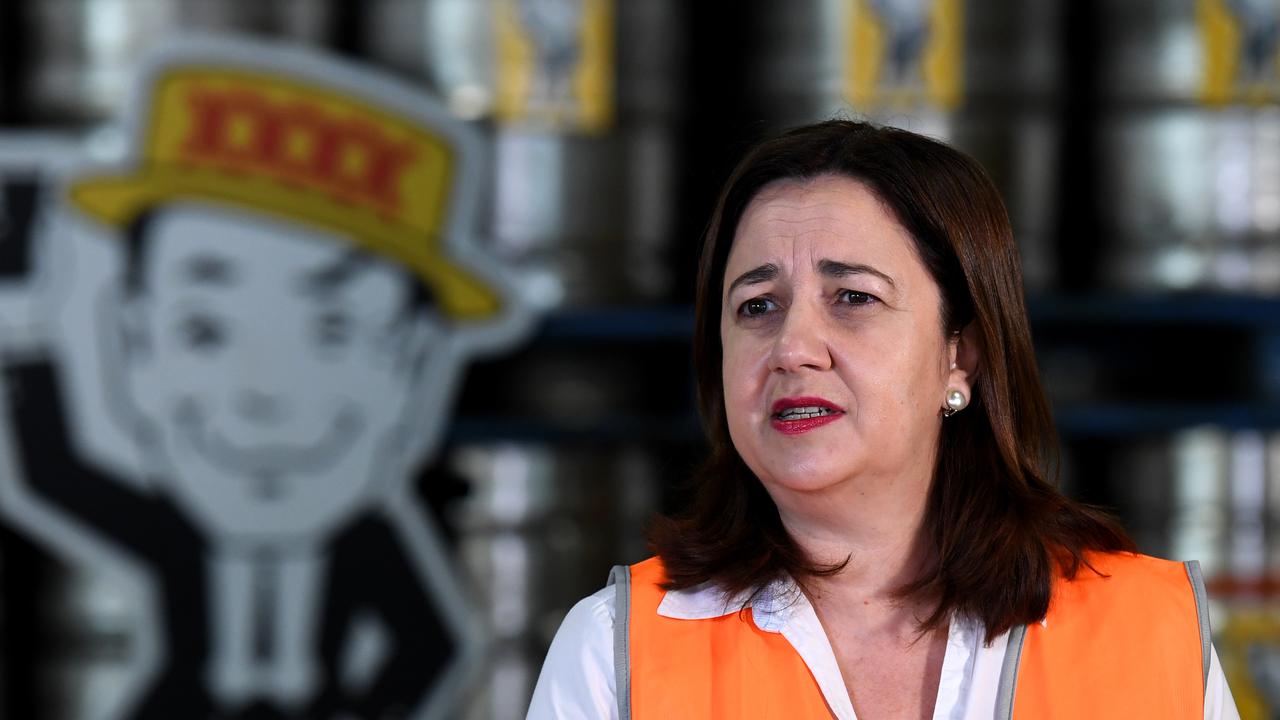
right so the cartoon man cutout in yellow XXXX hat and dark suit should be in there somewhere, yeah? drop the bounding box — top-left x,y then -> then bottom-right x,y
0,41 -> 524,720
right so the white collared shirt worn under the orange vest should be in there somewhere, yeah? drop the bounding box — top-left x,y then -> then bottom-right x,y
529,580 -> 1240,720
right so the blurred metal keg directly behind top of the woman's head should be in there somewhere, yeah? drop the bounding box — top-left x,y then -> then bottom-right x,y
751,0 -> 1060,290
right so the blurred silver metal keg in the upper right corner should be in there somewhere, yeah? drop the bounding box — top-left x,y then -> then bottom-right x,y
1098,0 -> 1280,293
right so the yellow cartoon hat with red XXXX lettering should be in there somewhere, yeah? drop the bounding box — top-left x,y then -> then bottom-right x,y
69,65 -> 500,320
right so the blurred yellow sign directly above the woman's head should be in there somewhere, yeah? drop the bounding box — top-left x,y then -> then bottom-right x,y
845,0 -> 964,110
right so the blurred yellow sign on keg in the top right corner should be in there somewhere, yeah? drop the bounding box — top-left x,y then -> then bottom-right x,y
1196,0 -> 1280,105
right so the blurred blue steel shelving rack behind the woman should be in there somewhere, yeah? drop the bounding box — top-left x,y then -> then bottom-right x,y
449,295 -> 1280,443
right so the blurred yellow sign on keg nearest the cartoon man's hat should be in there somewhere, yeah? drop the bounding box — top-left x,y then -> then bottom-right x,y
492,0 -> 614,132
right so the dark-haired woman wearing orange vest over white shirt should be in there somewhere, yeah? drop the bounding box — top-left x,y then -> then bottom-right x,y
530,120 -> 1236,720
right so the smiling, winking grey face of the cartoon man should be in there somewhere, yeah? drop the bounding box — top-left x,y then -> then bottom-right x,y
124,204 -> 442,538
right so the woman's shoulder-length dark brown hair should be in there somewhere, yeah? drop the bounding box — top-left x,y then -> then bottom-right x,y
649,120 -> 1133,642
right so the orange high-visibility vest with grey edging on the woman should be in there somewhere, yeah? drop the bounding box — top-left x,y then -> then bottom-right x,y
609,553 -> 1210,720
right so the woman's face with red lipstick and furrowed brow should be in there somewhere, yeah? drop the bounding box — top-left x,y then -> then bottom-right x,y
721,176 -> 969,501
